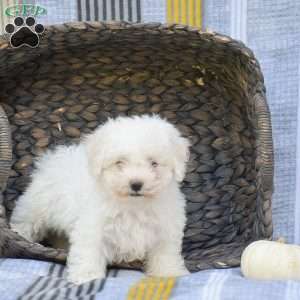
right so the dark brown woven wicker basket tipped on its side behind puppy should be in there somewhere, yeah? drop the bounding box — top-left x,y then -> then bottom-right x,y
0,22 -> 273,271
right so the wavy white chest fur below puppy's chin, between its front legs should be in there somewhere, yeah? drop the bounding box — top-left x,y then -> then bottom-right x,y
103,209 -> 160,262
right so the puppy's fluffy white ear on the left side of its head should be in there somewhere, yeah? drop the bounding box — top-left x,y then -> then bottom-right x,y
85,127 -> 105,176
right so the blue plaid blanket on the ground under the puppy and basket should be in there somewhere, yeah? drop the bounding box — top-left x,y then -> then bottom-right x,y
0,259 -> 300,300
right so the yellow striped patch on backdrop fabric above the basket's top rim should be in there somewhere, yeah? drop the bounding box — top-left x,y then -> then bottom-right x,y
166,0 -> 202,27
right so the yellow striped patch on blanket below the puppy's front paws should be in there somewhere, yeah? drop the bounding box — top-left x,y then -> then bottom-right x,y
127,277 -> 175,300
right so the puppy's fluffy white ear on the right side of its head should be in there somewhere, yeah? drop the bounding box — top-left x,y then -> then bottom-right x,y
172,129 -> 190,182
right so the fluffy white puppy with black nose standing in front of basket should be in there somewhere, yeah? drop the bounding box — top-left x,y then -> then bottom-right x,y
11,115 -> 189,284
